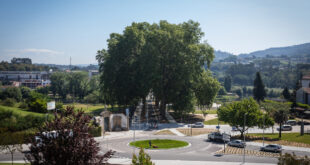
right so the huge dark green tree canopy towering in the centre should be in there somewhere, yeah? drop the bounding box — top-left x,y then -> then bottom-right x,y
96,20 -> 214,116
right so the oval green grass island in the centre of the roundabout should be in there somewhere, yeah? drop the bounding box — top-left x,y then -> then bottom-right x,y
130,139 -> 188,149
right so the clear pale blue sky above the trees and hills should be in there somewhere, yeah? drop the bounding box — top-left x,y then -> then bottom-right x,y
0,0 -> 310,64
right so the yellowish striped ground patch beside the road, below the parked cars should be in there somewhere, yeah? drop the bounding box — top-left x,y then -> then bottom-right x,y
216,146 -> 280,157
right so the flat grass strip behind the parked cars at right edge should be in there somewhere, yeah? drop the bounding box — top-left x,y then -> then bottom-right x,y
249,133 -> 310,145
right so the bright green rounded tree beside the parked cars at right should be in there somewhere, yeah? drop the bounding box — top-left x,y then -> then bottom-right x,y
218,98 -> 272,137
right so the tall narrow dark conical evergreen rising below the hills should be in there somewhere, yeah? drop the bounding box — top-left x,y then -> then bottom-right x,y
253,72 -> 266,102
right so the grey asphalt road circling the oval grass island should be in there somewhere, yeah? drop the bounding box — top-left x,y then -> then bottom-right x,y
100,135 -> 278,163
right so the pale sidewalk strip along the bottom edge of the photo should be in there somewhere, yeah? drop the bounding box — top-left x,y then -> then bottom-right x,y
109,158 -> 274,165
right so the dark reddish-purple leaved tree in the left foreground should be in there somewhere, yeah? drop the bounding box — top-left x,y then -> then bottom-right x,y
26,107 -> 114,165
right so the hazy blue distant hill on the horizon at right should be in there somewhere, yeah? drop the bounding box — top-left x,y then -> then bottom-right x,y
238,43 -> 310,58
